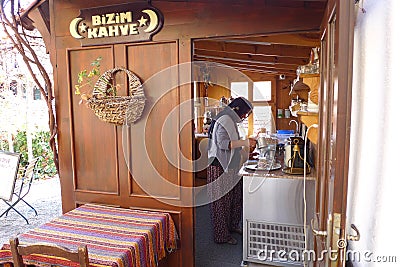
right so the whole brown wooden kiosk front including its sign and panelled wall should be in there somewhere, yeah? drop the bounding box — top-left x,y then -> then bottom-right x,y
21,0 -> 356,267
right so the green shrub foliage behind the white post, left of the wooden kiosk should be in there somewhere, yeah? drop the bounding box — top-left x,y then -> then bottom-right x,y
14,131 -> 57,178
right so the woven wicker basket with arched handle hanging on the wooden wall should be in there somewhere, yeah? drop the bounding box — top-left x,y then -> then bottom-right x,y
87,67 -> 145,125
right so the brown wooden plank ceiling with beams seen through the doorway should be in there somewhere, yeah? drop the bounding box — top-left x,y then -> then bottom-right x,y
193,32 -> 320,76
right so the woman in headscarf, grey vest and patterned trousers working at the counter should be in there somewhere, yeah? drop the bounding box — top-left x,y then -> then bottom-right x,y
207,97 -> 256,245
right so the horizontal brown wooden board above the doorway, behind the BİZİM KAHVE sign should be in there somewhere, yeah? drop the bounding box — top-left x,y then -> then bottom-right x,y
55,0 -> 324,40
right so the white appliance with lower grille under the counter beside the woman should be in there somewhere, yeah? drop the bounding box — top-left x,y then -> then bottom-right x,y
242,176 -> 315,266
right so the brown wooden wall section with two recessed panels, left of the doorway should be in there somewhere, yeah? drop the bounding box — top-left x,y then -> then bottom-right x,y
64,40 -> 193,266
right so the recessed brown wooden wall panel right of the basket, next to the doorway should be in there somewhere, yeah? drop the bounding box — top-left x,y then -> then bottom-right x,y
126,42 -> 180,199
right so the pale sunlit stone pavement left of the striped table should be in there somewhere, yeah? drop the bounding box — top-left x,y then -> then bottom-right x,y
0,177 -> 62,247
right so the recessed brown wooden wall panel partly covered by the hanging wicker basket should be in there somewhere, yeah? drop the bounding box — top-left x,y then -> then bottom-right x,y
66,47 -> 119,194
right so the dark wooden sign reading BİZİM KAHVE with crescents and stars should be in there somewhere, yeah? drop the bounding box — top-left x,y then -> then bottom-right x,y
69,2 -> 164,46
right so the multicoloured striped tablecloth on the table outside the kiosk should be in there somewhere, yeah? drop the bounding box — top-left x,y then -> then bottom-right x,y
0,204 -> 177,267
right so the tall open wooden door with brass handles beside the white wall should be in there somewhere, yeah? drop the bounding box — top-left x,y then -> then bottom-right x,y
313,0 -> 354,266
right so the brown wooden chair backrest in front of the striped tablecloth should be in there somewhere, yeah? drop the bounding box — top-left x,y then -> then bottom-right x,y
10,238 -> 89,267
